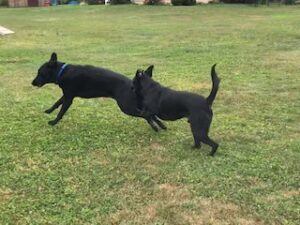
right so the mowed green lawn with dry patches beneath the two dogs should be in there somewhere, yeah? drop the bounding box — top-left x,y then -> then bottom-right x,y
0,5 -> 300,225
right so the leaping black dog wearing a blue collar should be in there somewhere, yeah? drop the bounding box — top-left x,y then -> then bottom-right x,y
32,53 -> 166,131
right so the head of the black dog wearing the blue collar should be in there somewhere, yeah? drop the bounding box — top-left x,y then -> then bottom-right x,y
32,52 -> 60,87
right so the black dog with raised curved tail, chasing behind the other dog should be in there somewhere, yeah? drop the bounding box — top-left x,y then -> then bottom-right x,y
133,65 -> 220,156
